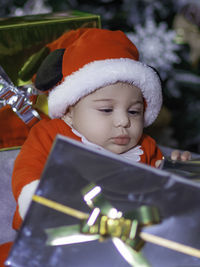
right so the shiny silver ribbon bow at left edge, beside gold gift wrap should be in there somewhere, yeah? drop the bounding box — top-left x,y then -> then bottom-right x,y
0,66 -> 41,126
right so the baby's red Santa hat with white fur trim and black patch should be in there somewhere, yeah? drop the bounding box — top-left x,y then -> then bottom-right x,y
35,28 -> 162,127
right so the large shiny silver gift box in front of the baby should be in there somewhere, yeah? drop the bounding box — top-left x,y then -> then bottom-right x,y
6,135 -> 200,267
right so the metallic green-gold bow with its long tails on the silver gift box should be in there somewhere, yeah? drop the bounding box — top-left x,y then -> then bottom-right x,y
39,184 -> 160,267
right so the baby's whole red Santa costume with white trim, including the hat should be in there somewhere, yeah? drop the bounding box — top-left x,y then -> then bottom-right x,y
0,28 -> 162,266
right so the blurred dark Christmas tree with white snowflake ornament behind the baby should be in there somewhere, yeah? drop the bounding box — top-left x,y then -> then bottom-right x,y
0,0 -> 200,152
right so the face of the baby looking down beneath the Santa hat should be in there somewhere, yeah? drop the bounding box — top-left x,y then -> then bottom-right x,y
63,82 -> 144,154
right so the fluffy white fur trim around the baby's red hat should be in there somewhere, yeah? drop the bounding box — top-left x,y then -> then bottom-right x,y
48,58 -> 162,127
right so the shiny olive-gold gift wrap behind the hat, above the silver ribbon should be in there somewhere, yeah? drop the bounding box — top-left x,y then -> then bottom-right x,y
0,11 -> 100,86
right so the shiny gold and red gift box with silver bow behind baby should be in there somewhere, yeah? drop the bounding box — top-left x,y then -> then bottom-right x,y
0,11 -> 100,150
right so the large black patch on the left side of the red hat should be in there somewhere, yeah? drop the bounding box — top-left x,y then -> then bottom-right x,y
35,49 -> 65,91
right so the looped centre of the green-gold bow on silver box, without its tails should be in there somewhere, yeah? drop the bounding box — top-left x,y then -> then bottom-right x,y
81,184 -> 160,251
